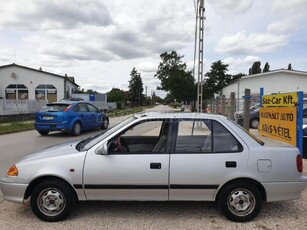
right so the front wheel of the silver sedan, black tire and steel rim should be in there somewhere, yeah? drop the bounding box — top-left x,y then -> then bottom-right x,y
30,180 -> 77,222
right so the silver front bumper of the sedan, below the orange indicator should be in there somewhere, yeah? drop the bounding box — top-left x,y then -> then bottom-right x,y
0,181 -> 28,203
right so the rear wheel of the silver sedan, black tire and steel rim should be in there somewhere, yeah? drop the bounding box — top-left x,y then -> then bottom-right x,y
217,182 -> 262,222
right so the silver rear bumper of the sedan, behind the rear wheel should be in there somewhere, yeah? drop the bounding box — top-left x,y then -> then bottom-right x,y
262,176 -> 307,202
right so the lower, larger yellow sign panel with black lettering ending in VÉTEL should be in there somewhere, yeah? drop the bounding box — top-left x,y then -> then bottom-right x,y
259,107 -> 297,146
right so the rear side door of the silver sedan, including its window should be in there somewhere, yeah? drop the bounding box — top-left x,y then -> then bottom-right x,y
169,119 -> 249,200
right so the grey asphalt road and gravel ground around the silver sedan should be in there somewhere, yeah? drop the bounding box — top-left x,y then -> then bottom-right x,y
0,106 -> 307,230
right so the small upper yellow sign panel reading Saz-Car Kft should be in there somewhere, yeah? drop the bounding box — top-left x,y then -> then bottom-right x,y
262,93 -> 298,107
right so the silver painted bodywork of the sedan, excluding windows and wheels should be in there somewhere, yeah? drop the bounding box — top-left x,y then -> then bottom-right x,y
0,113 -> 307,202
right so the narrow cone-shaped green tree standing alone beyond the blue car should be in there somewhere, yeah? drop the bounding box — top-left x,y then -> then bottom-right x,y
129,67 -> 144,106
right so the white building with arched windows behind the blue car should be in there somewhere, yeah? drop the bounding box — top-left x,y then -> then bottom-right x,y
0,63 -> 79,102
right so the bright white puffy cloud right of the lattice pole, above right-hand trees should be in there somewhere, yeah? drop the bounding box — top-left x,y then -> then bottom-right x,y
216,31 -> 288,54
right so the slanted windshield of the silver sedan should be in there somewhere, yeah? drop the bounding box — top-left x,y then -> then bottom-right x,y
78,116 -> 136,151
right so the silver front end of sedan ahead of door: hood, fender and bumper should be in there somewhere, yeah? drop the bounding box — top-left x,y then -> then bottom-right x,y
0,141 -> 86,202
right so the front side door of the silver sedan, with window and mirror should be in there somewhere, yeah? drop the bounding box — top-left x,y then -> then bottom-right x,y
83,120 -> 170,200
